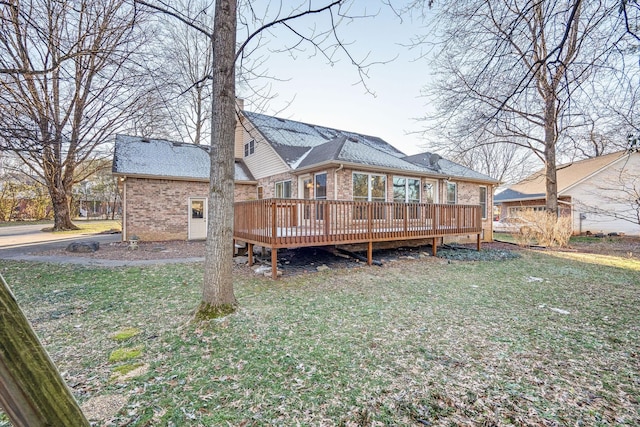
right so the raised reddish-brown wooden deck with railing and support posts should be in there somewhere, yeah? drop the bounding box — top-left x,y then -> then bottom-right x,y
233,199 -> 482,278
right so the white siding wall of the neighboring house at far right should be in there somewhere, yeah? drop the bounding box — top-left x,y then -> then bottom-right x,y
567,153 -> 640,235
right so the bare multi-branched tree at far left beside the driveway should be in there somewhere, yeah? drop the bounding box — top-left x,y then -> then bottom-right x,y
0,0 -> 151,230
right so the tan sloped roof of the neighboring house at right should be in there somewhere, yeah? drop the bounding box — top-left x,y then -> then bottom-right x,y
495,151 -> 626,202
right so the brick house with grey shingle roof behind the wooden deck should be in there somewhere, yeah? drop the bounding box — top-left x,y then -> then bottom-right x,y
113,111 -> 497,244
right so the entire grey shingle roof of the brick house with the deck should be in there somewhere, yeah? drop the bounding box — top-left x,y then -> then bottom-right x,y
113,111 -> 497,183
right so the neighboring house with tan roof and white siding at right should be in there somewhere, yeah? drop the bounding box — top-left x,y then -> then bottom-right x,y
494,149 -> 640,235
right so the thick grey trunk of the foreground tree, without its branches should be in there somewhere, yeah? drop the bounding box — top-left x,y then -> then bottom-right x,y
196,0 -> 237,319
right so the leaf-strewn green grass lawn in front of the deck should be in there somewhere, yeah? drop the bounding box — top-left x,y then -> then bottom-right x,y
0,251 -> 640,426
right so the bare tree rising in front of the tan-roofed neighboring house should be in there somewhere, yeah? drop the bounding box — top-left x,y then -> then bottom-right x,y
412,0 -> 635,213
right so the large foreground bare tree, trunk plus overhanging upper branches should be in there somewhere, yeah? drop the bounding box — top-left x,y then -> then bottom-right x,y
135,0 -> 376,318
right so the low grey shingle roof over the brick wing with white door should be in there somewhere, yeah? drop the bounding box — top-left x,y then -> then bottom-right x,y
112,135 -> 254,181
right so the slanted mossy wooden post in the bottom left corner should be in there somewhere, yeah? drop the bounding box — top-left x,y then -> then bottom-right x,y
0,275 -> 89,427
